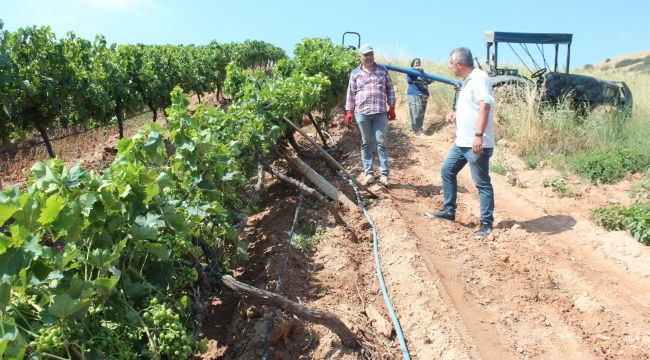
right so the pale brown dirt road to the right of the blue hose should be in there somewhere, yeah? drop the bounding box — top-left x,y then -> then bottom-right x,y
354,120 -> 650,359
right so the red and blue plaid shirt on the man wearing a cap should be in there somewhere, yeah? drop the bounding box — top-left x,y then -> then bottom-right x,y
345,64 -> 395,115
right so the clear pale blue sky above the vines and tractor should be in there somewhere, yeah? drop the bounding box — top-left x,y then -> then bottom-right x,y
0,0 -> 650,68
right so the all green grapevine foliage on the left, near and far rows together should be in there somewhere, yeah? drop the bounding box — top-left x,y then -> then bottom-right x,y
0,28 -> 349,359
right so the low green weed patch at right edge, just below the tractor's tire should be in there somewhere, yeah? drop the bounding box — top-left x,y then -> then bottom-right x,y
573,147 -> 650,184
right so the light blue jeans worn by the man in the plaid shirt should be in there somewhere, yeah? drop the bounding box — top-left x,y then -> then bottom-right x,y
354,113 -> 389,176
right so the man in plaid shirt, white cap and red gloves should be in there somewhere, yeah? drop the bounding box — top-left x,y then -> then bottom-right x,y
343,45 -> 396,186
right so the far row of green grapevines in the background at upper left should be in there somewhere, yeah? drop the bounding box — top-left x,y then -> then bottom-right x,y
0,27 -> 286,150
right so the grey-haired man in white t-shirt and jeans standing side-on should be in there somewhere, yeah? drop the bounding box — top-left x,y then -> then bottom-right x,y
425,48 -> 496,239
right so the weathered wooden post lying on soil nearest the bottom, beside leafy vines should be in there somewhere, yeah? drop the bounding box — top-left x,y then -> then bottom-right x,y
221,275 -> 359,348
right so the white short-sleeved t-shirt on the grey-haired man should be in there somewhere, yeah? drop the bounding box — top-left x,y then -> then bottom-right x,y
456,68 -> 496,148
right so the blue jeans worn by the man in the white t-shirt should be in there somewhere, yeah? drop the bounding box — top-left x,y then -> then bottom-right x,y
440,144 -> 494,226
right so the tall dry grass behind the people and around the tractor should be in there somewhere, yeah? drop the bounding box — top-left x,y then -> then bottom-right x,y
378,54 -> 650,175
